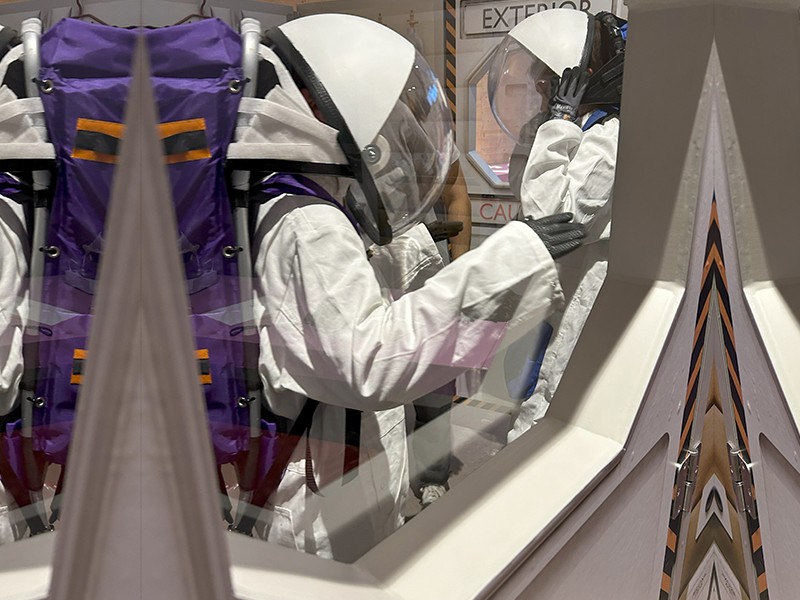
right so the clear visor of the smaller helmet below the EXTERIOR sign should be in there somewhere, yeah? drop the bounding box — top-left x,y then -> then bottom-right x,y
488,36 -> 556,142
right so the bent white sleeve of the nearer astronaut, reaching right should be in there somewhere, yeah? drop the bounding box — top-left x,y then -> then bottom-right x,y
268,209 -> 562,410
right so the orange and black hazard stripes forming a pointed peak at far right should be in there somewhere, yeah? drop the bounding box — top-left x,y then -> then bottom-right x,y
659,197 -> 769,600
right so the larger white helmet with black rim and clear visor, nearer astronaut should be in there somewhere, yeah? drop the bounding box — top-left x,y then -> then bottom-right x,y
265,14 -> 454,244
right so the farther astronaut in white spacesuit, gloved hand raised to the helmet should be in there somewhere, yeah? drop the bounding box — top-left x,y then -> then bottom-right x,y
489,9 -> 621,441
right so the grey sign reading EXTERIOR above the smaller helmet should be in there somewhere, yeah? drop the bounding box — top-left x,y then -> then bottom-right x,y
461,0 -> 612,36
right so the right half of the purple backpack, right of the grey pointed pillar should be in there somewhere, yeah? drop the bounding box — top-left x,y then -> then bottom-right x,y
144,19 -> 266,524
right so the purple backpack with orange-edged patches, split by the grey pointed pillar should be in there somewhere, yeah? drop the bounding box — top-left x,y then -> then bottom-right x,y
8,19 -> 275,508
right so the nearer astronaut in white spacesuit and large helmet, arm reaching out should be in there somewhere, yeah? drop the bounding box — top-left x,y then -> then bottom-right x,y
231,15 -> 583,560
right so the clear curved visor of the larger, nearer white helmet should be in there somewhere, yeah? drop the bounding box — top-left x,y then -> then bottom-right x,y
350,53 -> 454,241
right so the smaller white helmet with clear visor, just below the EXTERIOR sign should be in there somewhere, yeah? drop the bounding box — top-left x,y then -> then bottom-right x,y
488,8 -> 594,142
